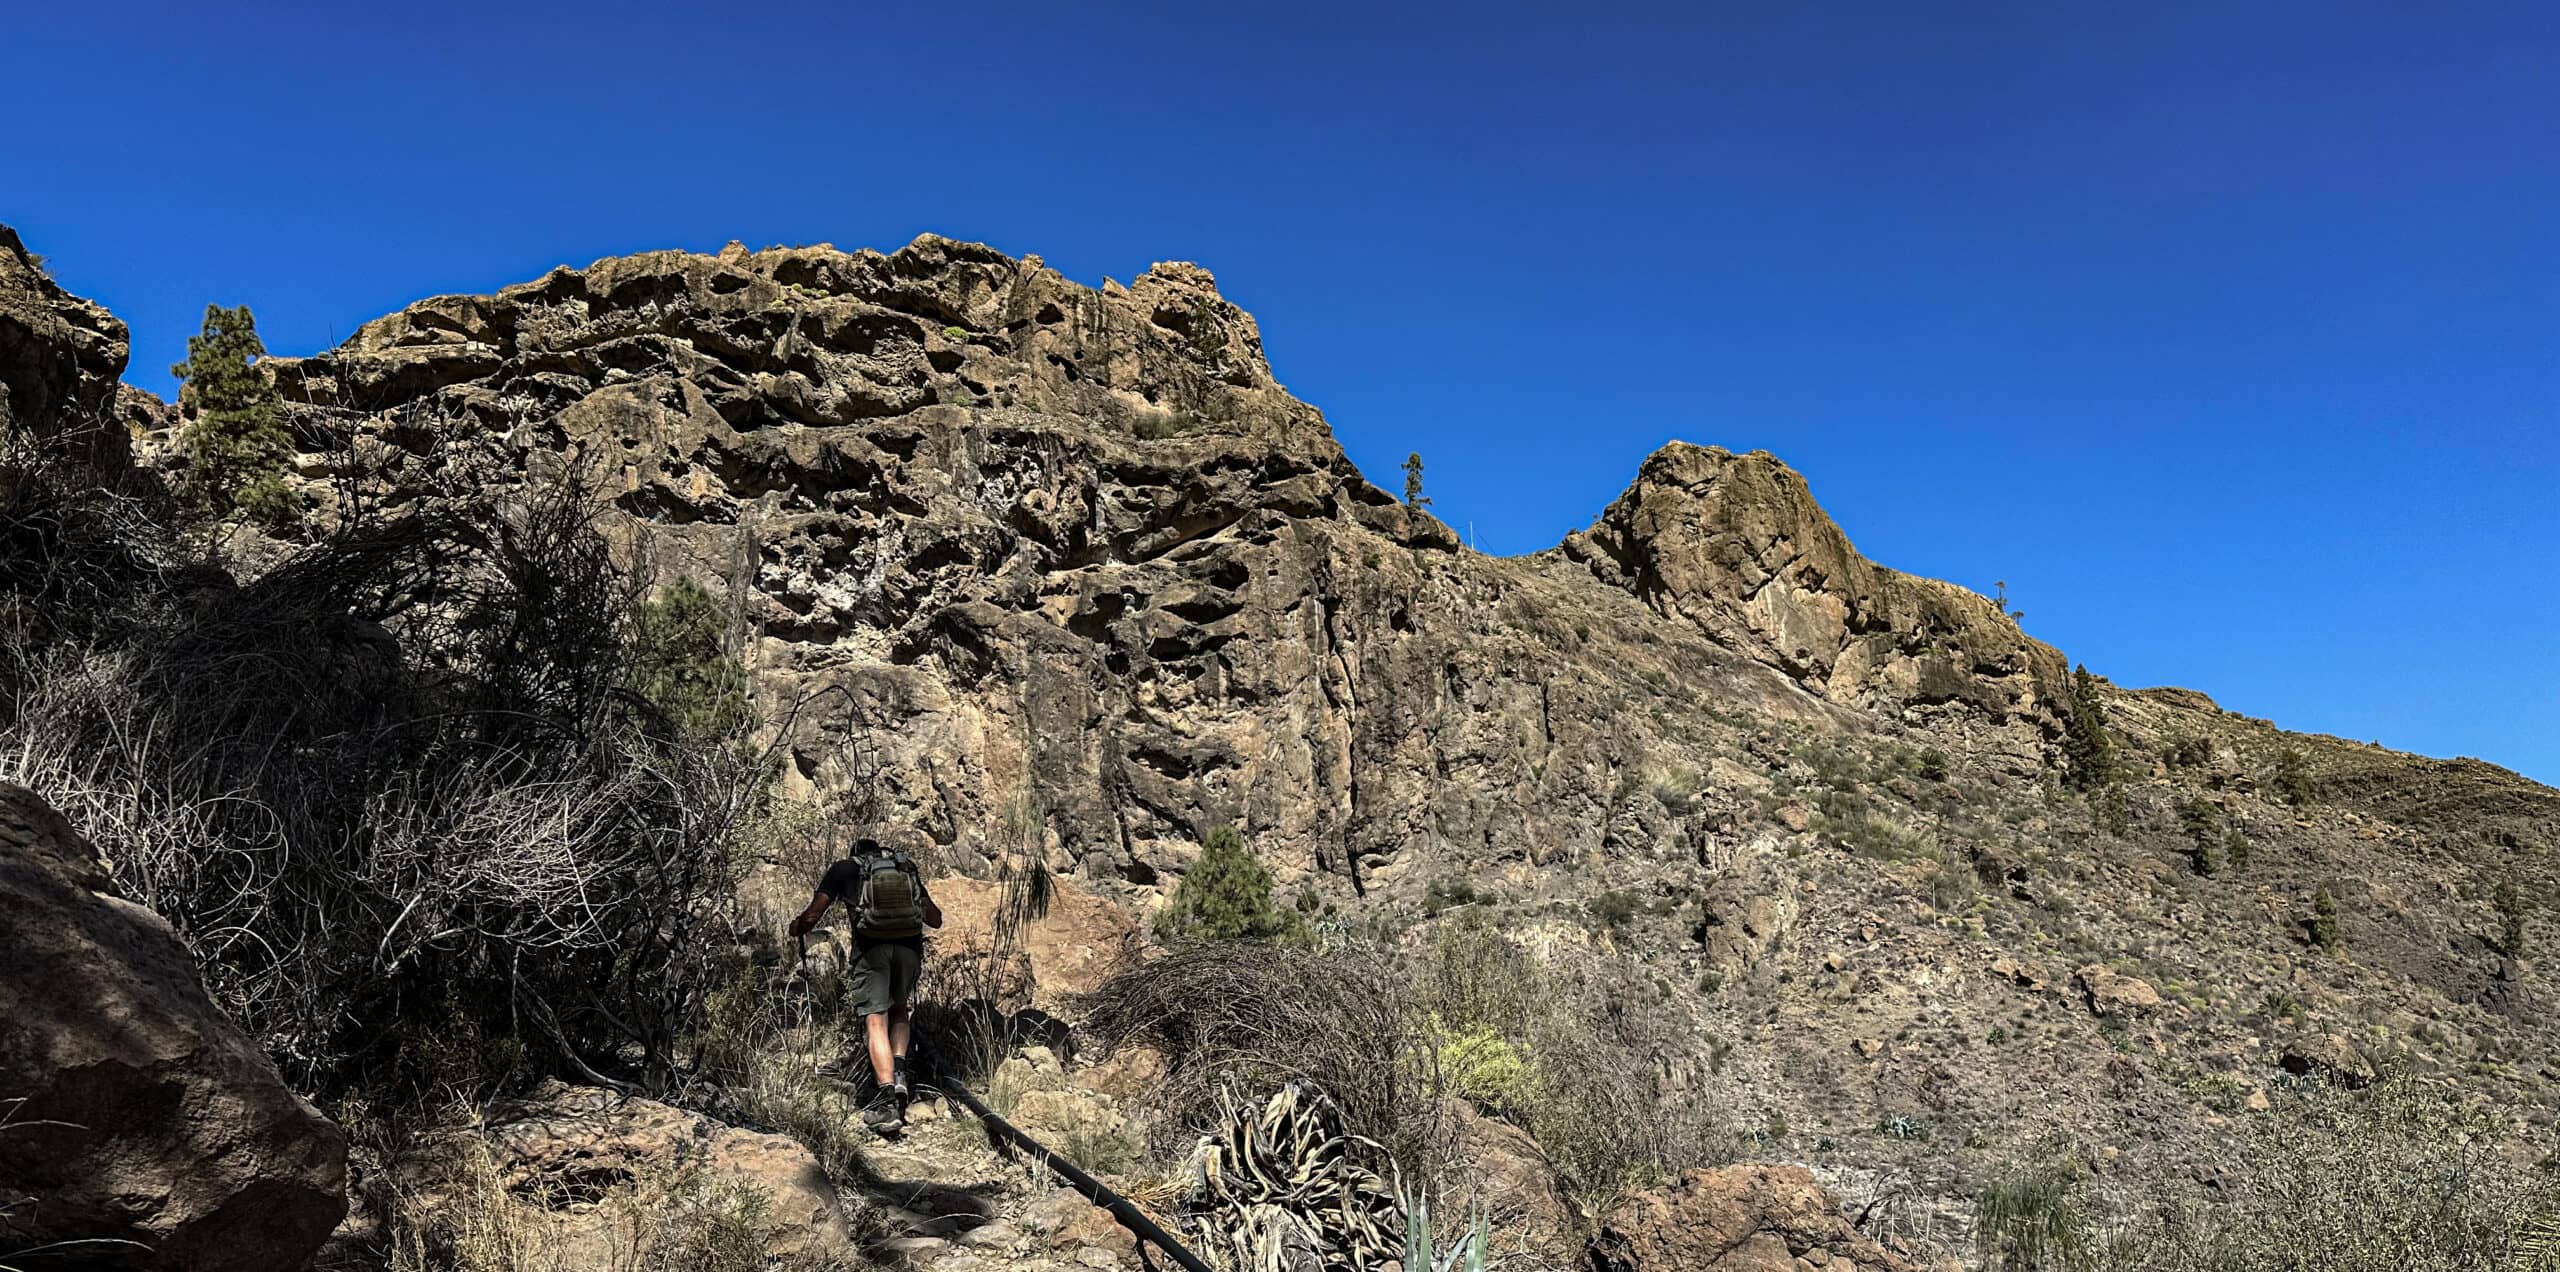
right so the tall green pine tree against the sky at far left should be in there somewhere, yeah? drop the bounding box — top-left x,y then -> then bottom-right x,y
169,305 -> 297,525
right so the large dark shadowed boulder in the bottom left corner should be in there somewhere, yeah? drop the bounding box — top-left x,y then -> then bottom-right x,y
0,786 -> 346,1272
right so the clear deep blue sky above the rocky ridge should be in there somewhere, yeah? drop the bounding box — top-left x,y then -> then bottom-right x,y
0,0 -> 2560,781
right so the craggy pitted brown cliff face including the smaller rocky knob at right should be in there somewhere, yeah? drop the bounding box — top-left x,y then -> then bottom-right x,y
244,238 -> 2058,891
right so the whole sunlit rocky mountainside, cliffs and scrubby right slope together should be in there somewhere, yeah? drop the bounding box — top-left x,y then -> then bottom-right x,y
74,220 -> 2560,1223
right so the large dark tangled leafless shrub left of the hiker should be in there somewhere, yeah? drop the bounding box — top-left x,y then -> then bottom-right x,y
0,460 -> 763,1093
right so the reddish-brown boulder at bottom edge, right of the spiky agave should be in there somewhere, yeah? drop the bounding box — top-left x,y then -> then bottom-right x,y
1582,1162 -> 1917,1272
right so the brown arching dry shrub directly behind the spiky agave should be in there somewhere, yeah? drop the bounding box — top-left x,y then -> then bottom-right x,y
1083,942 -> 1446,1180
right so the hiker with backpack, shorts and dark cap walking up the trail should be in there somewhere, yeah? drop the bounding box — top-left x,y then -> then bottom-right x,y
791,837 -> 942,1131
